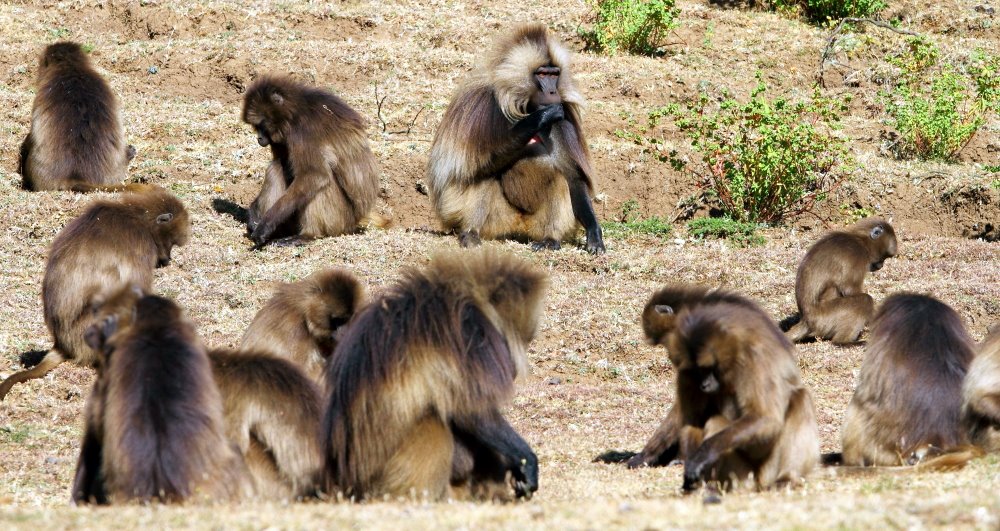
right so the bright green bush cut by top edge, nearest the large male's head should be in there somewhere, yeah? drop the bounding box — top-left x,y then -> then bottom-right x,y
579,0 -> 680,55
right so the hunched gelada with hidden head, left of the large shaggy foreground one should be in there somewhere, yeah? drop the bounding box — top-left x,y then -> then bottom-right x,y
208,349 -> 323,500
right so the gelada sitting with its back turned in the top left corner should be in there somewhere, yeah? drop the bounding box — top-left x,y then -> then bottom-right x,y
18,42 -> 135,192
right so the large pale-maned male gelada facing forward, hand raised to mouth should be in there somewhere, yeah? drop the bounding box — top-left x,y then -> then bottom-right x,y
428,24 -> 604,254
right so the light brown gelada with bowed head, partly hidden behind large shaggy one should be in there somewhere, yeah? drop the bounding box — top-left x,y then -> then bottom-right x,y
240,269 -> 367,382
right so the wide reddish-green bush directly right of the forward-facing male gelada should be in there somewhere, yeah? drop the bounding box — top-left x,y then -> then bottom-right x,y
638,74 -> 847,223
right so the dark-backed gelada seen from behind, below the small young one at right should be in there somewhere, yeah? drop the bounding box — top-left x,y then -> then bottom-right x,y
843,293 -> 973,466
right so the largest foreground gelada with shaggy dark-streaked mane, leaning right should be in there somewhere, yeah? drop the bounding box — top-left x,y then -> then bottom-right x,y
323,252 -> 546,499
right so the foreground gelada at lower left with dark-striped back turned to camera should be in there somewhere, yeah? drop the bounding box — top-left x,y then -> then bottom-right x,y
73,285 -> 253,504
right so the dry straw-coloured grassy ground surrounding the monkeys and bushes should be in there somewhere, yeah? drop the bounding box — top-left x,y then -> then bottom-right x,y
0,0 -> 1000,529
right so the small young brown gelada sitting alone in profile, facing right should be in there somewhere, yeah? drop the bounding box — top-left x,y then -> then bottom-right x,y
787,218 -> 896,343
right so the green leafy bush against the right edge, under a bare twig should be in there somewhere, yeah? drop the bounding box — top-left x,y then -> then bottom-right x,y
881,37 -> 1000,161
